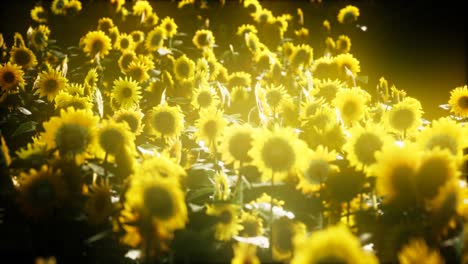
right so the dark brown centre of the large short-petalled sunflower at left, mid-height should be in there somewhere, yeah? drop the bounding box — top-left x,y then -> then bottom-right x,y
55,124 -> 88,154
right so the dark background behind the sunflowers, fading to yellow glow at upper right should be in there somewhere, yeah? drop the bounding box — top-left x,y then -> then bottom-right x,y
0,0 -> 468,119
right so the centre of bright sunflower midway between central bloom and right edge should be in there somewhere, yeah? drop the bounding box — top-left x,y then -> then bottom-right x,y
353,132 -> 383,165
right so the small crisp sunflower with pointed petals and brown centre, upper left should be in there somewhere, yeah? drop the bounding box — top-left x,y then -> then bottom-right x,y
111,77 -> 141,109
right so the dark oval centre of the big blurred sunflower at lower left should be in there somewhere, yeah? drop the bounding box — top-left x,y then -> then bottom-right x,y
143,186 -> 175,220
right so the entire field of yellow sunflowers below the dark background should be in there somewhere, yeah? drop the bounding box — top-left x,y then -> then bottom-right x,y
0,0 -> 468,264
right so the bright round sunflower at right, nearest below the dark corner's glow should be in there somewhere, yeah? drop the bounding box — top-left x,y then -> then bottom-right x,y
383,97 -> 423,135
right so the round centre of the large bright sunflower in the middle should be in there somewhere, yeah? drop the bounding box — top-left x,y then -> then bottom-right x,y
261,137 -> 296,171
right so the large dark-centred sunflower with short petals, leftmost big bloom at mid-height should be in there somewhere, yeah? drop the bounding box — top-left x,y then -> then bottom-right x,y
42,107 -> 99,159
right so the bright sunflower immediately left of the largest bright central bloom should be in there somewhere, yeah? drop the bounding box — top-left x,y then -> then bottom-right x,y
220,123 -> 256,164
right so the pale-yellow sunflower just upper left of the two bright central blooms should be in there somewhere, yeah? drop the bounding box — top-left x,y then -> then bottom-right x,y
195,107 -> 227,150
